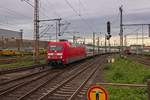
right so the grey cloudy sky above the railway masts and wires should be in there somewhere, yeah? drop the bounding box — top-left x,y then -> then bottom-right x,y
0,0 -> 150,39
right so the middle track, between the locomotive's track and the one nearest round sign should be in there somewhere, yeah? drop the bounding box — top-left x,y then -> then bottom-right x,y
0,56 -> 99,100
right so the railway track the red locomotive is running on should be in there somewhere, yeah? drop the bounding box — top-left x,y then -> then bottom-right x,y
0,54 -> 95,84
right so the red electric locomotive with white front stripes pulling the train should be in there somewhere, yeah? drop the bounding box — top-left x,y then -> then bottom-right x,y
47,41 -> 86,65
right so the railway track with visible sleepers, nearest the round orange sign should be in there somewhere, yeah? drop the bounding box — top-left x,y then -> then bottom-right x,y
38,58 -> 99,100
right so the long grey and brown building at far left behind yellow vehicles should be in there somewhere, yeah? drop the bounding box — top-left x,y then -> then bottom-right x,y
0,29 -> 47,51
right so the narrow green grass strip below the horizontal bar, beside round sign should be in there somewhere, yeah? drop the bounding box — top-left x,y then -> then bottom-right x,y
107,86 -> 148,100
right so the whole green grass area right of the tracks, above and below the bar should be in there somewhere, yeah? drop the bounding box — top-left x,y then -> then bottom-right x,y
104,57 -> 150,100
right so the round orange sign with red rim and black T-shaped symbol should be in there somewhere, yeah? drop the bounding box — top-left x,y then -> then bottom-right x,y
87,85 -> 108,100
